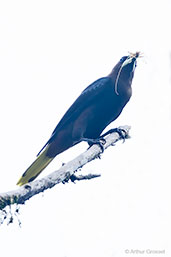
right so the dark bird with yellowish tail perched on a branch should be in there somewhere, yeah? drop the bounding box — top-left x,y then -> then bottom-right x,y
17,52 -> 140,186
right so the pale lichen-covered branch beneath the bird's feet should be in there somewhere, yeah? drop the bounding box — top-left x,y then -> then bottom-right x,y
0,126 -> 130,210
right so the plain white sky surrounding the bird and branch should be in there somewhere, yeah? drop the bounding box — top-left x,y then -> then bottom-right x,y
0,0 -> 171,257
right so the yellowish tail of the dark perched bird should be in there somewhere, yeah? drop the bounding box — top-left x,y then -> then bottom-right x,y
17,147 -> 54,186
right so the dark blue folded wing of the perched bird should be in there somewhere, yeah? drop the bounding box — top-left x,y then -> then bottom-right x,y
38,77 -> 112,155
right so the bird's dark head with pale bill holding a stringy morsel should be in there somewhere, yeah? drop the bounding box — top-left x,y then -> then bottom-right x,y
109,52 -> 141,95
